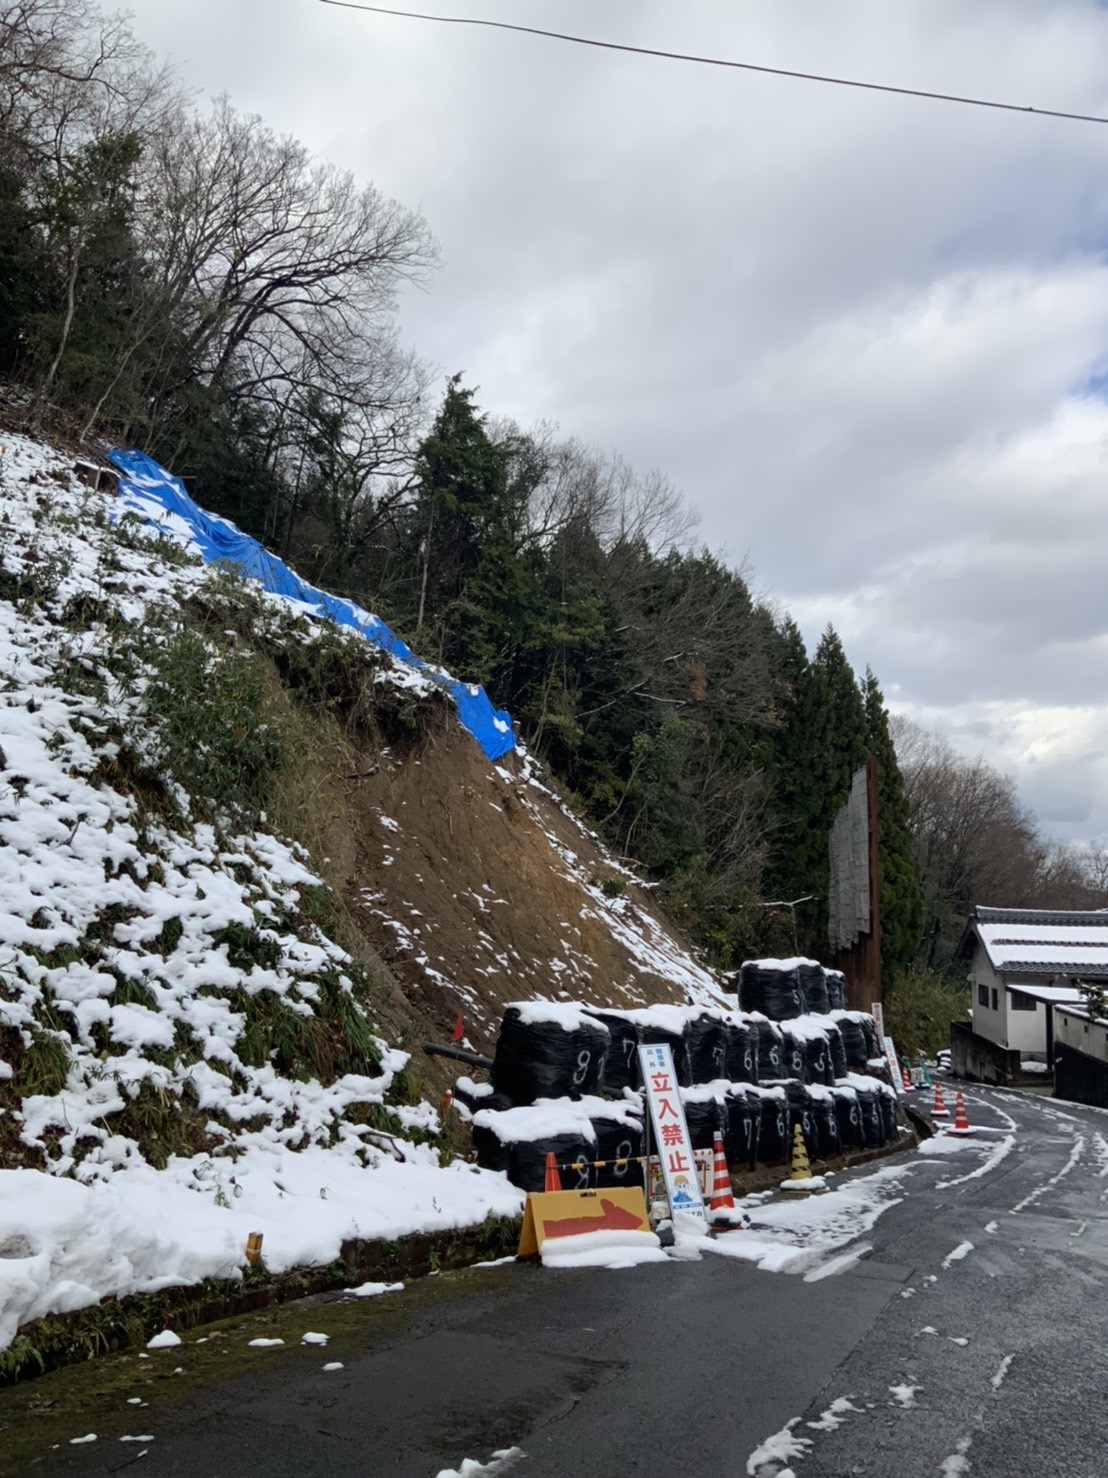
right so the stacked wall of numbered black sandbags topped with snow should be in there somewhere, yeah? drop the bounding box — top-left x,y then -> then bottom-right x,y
466,958 -> 900,1190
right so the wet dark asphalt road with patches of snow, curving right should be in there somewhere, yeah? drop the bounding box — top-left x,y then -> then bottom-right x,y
8,1088 -> 1108,1478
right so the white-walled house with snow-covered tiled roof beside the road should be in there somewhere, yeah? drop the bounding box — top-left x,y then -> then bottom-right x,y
956,906 -> 1108,1076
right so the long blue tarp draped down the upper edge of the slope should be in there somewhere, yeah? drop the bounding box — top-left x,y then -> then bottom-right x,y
109,449 -> 516,760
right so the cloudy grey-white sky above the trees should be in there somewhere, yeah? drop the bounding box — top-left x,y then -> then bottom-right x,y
129,0 -> 1108,840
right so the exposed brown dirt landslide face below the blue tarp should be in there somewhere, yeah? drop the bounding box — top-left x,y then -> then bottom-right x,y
314,711 -> 729,1051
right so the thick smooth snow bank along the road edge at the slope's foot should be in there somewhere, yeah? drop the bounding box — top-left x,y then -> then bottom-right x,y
0,1145 -> 523,1348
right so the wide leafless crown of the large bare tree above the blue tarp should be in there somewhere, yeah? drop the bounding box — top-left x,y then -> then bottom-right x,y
149,99 -> 434,422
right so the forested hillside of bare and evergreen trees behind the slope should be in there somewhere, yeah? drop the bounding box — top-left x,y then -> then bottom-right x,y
0,0 -> 1105,1005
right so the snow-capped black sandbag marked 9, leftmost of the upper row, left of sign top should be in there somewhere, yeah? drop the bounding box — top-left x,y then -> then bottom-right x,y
492,1001 -> 610,1104
